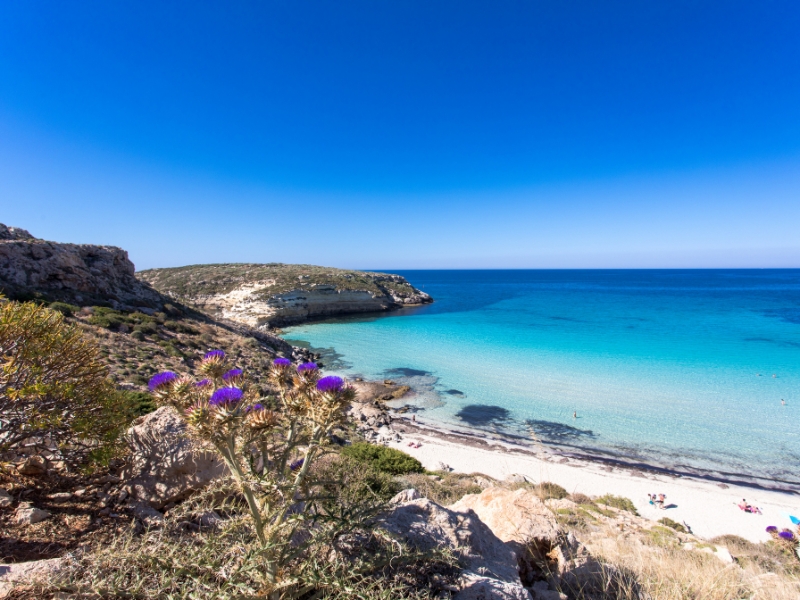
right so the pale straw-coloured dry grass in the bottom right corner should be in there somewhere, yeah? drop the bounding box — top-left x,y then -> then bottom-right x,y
586,526 -> 800,600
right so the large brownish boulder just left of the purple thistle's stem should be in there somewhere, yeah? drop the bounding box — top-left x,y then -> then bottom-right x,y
122,406 -> 227,509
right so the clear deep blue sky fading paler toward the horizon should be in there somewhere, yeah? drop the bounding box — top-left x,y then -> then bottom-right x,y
0,0 -> 800,269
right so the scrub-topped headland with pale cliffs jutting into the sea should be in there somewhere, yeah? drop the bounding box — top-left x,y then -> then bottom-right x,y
137,264 -> 433,327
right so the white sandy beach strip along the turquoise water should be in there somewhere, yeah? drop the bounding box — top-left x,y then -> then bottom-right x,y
391,421 -> 800,542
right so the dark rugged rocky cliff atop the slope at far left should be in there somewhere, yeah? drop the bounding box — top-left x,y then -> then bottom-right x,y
0,224 -> 162,309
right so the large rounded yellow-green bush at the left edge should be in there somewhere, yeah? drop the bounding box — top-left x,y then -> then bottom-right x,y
0,301 -> 131,466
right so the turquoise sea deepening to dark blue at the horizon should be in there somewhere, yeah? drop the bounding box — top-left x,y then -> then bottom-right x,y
286,270 -> 800,491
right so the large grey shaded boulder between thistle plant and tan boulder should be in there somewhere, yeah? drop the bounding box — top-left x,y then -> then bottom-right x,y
382,498 -> 520,583
